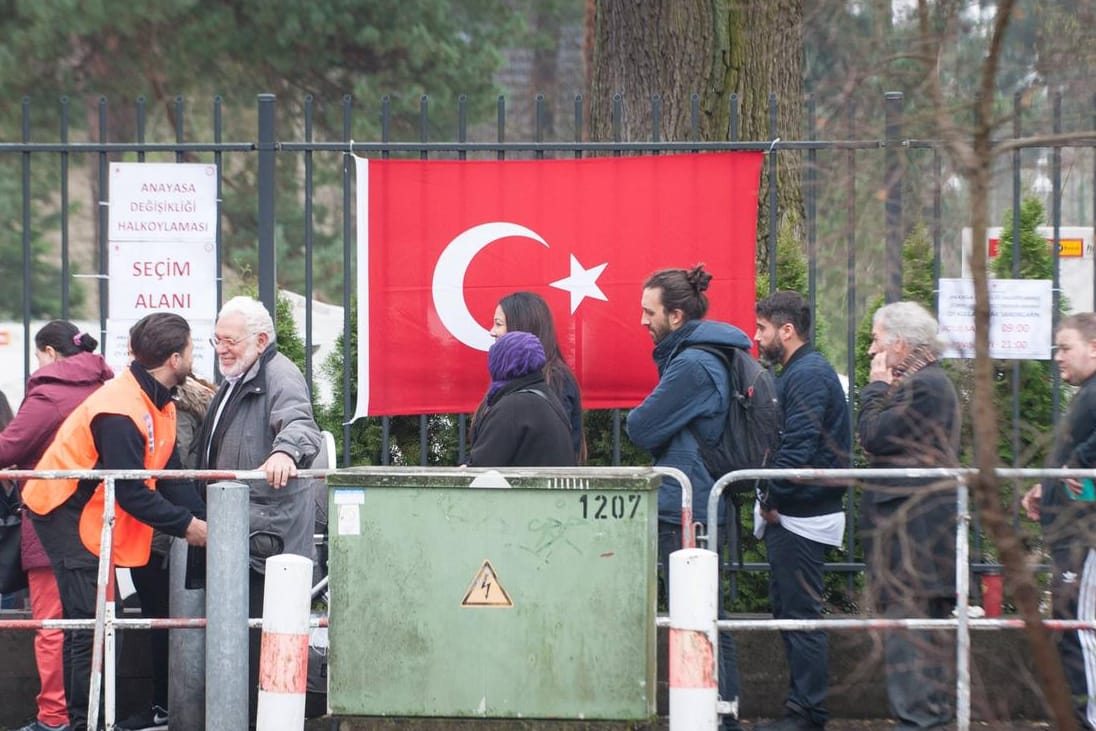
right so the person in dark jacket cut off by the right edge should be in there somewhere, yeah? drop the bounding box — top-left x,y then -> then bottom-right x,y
1023,312 -> 1096,729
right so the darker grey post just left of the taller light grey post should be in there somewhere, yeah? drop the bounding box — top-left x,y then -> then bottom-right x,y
168,538 -> 205,731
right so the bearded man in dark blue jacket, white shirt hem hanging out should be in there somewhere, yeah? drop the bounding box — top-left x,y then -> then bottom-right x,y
754,292 -> 852,731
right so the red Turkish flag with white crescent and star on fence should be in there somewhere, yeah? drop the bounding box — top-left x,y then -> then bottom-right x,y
355,152 -> 762,418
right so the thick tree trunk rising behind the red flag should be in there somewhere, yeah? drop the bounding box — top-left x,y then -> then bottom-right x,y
590,0 -> 803,267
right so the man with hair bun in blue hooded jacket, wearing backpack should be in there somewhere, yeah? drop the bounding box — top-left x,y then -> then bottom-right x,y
628,264 -> 750,731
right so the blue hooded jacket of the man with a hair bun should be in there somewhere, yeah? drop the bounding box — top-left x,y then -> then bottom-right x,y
628,320 -> 751,525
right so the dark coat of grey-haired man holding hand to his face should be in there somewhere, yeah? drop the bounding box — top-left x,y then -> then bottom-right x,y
857,364 -> 961,606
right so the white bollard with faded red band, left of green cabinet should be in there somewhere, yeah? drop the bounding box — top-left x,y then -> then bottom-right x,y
255,553 -> 312,731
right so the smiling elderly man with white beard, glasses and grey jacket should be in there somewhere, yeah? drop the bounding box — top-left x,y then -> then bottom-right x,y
196,297 -> 322,726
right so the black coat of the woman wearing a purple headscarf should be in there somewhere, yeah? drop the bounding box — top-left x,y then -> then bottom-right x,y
468,373 -> 575,467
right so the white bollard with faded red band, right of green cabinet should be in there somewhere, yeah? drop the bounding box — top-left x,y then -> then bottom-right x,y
669,548 -> 719,731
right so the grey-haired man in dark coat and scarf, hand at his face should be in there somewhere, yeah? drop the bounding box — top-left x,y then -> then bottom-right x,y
857,302 -> 960,730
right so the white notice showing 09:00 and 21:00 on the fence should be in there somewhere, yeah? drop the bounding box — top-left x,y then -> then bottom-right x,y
938,278 -> 1053,361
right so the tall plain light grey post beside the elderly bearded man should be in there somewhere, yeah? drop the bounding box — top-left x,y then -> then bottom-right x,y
205,482 -> 249,731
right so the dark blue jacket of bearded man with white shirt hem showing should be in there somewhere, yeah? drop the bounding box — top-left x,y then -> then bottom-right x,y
768,344 -> 853,517
